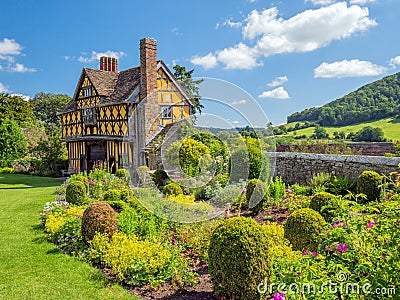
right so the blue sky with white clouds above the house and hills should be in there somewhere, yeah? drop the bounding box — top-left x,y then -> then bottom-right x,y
0,0 -> 400,126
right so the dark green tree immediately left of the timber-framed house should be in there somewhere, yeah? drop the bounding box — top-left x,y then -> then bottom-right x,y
30,92 -> 71,129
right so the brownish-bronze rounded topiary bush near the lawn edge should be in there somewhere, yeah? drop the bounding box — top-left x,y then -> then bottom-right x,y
82,202 -> 118,241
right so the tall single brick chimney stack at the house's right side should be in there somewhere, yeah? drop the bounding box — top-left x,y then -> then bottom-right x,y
140,38 -> 157,99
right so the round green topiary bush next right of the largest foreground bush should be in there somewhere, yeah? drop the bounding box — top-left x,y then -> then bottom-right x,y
284,208 -> 325,251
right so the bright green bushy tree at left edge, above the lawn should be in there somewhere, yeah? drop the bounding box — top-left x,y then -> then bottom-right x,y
0,119 -> 27,166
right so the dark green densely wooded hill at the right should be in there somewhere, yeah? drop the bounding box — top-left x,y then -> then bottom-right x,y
287,72 -> 400,126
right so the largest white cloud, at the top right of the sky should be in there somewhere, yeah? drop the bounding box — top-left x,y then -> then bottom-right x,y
243,2 -> 377,56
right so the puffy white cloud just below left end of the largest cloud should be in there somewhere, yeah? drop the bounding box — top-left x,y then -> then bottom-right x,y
217,43 -> 261,70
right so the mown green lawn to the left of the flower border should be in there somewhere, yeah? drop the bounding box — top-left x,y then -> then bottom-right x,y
0,174 -> 138,299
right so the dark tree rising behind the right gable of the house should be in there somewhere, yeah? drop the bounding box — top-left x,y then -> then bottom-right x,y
174,65 -> 204,113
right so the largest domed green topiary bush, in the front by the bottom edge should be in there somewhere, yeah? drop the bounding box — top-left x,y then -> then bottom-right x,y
208,217 -> 268,300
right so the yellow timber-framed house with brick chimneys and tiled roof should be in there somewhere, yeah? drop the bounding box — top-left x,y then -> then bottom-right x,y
59,38 -> 193,173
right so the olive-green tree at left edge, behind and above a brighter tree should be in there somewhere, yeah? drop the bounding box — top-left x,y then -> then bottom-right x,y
0,94 -> 37,128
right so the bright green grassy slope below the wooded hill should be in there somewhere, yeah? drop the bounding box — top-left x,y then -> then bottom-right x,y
285,118 -> 400,141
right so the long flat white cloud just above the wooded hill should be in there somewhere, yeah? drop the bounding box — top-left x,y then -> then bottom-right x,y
314,59 -> 387,78
